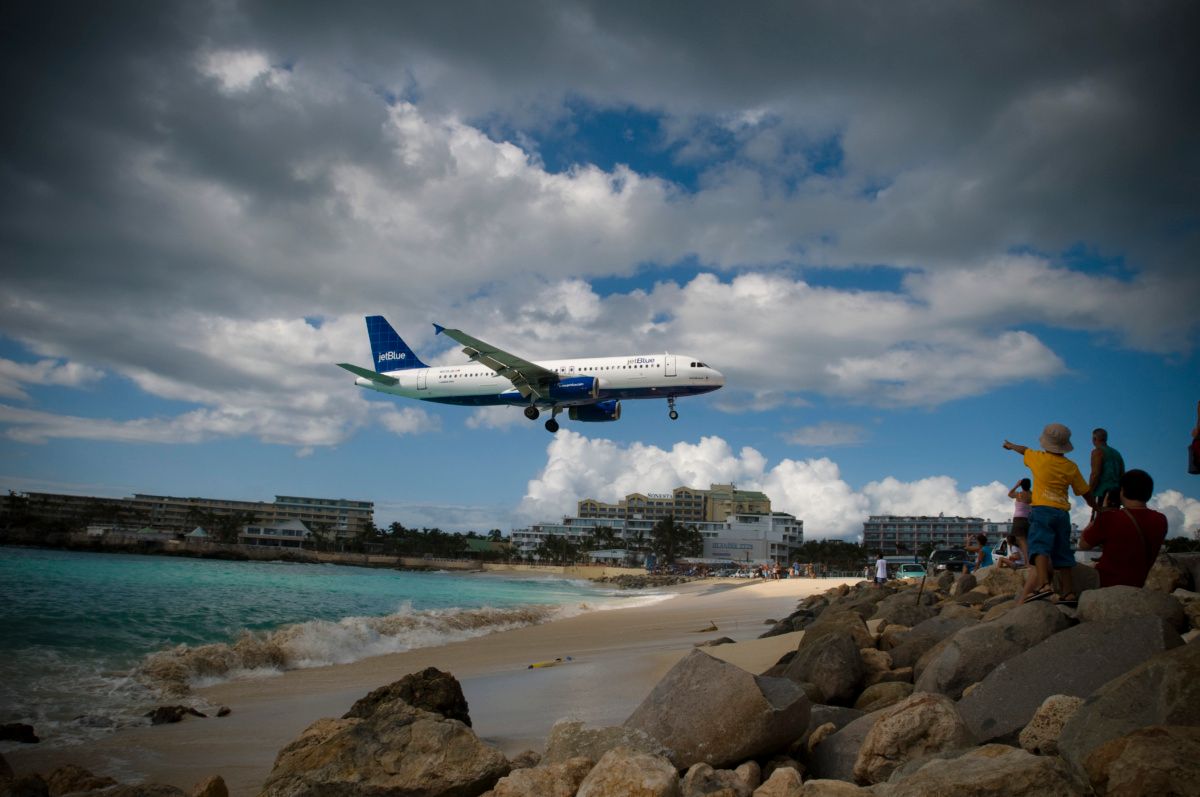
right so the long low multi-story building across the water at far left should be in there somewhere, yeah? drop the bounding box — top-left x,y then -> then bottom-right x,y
0,492 -> 374,537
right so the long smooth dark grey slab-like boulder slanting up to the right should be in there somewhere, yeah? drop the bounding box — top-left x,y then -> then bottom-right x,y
959,617 -> 1183,743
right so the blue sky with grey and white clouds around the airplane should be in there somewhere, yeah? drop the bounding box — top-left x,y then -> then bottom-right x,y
0,0 -> 1200,540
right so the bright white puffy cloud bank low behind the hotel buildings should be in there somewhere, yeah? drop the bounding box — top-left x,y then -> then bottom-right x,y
516,431 -> 1041,540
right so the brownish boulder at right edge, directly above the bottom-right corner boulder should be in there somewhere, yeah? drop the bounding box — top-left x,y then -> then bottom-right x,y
1058,643 -> 1200,773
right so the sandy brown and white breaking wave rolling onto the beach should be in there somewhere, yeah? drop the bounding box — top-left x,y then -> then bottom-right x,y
137,605 -> 561,695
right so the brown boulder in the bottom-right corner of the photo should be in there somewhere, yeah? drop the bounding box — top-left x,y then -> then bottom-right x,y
1085,725 -> 1200,797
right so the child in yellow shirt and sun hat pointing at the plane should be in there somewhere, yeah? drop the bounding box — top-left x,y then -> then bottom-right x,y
1004,424 -> 1096,603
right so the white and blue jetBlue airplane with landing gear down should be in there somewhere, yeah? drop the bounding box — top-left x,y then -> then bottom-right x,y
337,316 -> 725,433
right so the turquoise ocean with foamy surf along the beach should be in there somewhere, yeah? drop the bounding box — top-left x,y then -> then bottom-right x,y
0,547 -> 668,750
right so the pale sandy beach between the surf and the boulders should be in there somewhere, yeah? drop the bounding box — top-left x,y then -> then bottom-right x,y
5,579 -> 854,797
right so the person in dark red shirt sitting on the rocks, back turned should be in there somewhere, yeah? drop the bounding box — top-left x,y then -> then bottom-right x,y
1079,469 -> 1166,589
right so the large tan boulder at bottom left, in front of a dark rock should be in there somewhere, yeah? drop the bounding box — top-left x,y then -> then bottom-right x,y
262,700 -> 509,797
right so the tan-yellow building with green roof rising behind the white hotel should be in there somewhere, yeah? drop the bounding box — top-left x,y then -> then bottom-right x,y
577,484 -> 770,523
